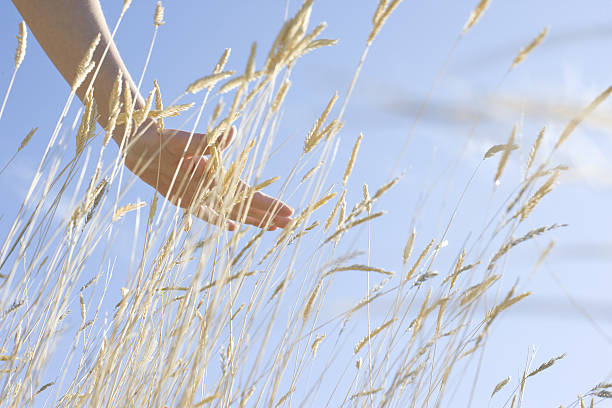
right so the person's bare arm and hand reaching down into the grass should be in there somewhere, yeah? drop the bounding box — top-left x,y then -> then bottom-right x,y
13,0 -> 293,230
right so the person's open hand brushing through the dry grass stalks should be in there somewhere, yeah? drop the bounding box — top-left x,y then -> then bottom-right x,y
120,125 -> 293,231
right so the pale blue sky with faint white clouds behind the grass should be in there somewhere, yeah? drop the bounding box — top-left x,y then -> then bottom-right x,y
0,0 -> 612,407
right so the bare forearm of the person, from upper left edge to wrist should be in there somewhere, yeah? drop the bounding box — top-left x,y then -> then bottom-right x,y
13,0 -> 143,141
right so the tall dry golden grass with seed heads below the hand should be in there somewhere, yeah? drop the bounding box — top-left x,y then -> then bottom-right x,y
0,0 -> 610,407
